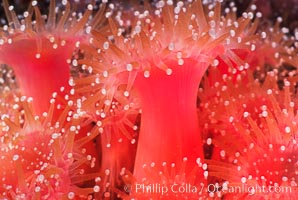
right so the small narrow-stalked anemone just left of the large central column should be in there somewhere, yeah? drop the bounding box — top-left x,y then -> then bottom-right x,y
71,45 -> 140,198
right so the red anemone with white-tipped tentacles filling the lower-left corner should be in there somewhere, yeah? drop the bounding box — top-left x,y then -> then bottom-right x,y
0,96 -> 100,199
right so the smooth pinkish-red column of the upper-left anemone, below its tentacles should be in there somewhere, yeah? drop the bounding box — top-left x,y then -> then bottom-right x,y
0,39 -> 74,114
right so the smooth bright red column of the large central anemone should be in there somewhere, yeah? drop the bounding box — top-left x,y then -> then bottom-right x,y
134,58 -> 208,181
